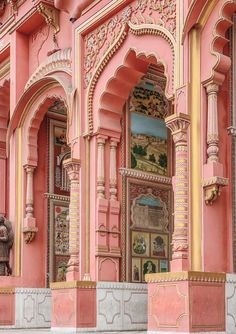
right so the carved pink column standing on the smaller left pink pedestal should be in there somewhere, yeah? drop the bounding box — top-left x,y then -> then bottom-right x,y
64,158 -> 80,281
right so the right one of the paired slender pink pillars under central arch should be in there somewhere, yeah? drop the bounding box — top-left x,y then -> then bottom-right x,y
110,138 -> 118,201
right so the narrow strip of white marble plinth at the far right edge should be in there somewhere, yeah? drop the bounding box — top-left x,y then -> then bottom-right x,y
225,274 -> 236,334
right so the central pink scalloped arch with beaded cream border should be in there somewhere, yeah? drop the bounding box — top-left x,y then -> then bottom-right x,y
86,23 -> 175,134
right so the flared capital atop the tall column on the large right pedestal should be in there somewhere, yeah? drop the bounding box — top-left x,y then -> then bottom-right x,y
165,113 -> 190,144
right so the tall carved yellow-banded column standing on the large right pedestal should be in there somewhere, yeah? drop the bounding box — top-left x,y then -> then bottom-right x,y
165,113 -> 190,271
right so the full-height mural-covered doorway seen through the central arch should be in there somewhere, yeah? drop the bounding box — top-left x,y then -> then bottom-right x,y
123,63 -> 172,283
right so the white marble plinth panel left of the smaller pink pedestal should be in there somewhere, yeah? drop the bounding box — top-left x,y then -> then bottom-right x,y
15,288 -> 51,328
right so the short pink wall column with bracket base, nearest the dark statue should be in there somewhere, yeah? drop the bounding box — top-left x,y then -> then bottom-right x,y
23,165 -> 38,243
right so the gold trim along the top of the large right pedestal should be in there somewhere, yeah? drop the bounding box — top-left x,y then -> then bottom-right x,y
145,271 -> 226,283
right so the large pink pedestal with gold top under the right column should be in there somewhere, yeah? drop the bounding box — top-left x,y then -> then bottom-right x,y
146,271 -> 226,334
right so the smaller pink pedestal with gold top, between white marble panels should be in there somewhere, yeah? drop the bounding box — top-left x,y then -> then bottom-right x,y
50,281 -> 96,330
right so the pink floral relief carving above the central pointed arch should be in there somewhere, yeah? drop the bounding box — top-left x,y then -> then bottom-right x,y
84,0 -> 176,88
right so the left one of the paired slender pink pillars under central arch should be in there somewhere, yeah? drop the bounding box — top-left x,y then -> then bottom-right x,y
97,136 -> 107,198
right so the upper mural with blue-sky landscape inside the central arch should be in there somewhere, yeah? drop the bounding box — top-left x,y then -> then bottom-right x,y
130,87 -> 168,176
